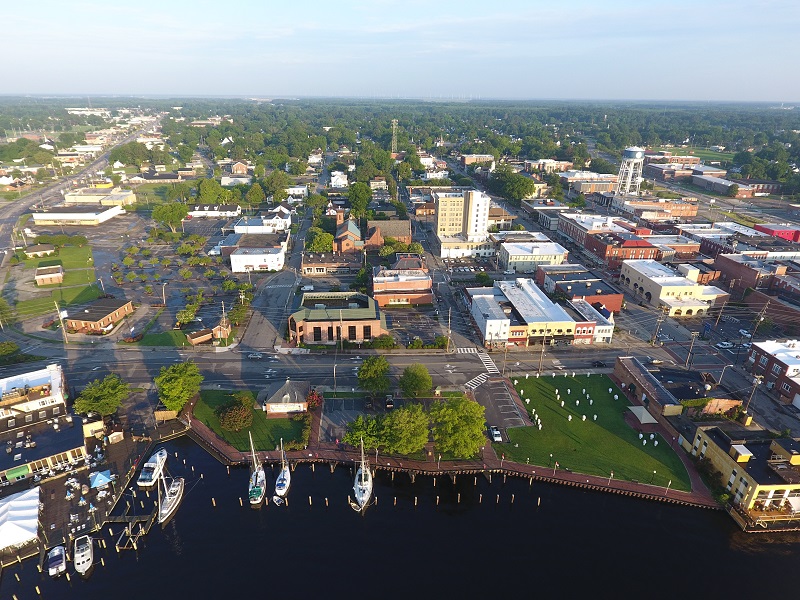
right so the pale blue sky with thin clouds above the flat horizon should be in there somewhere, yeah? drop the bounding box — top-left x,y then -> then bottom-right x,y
6,0 -> 800,104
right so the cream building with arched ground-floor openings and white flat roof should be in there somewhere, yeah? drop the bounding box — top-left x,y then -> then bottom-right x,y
619,259 -> 729,317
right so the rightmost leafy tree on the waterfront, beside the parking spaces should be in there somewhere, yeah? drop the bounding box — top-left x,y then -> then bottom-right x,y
430,396 -> 486,458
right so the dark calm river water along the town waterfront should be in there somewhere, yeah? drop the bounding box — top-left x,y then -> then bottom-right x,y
0,440 -> 800,600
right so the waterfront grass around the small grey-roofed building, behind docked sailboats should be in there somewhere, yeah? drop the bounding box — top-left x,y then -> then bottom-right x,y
194,390 -> 303,452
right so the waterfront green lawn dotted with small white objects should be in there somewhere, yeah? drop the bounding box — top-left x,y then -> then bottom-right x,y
510,375 -> 691,491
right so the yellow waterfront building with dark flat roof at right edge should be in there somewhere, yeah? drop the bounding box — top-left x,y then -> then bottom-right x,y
683,426 -> 800,528
